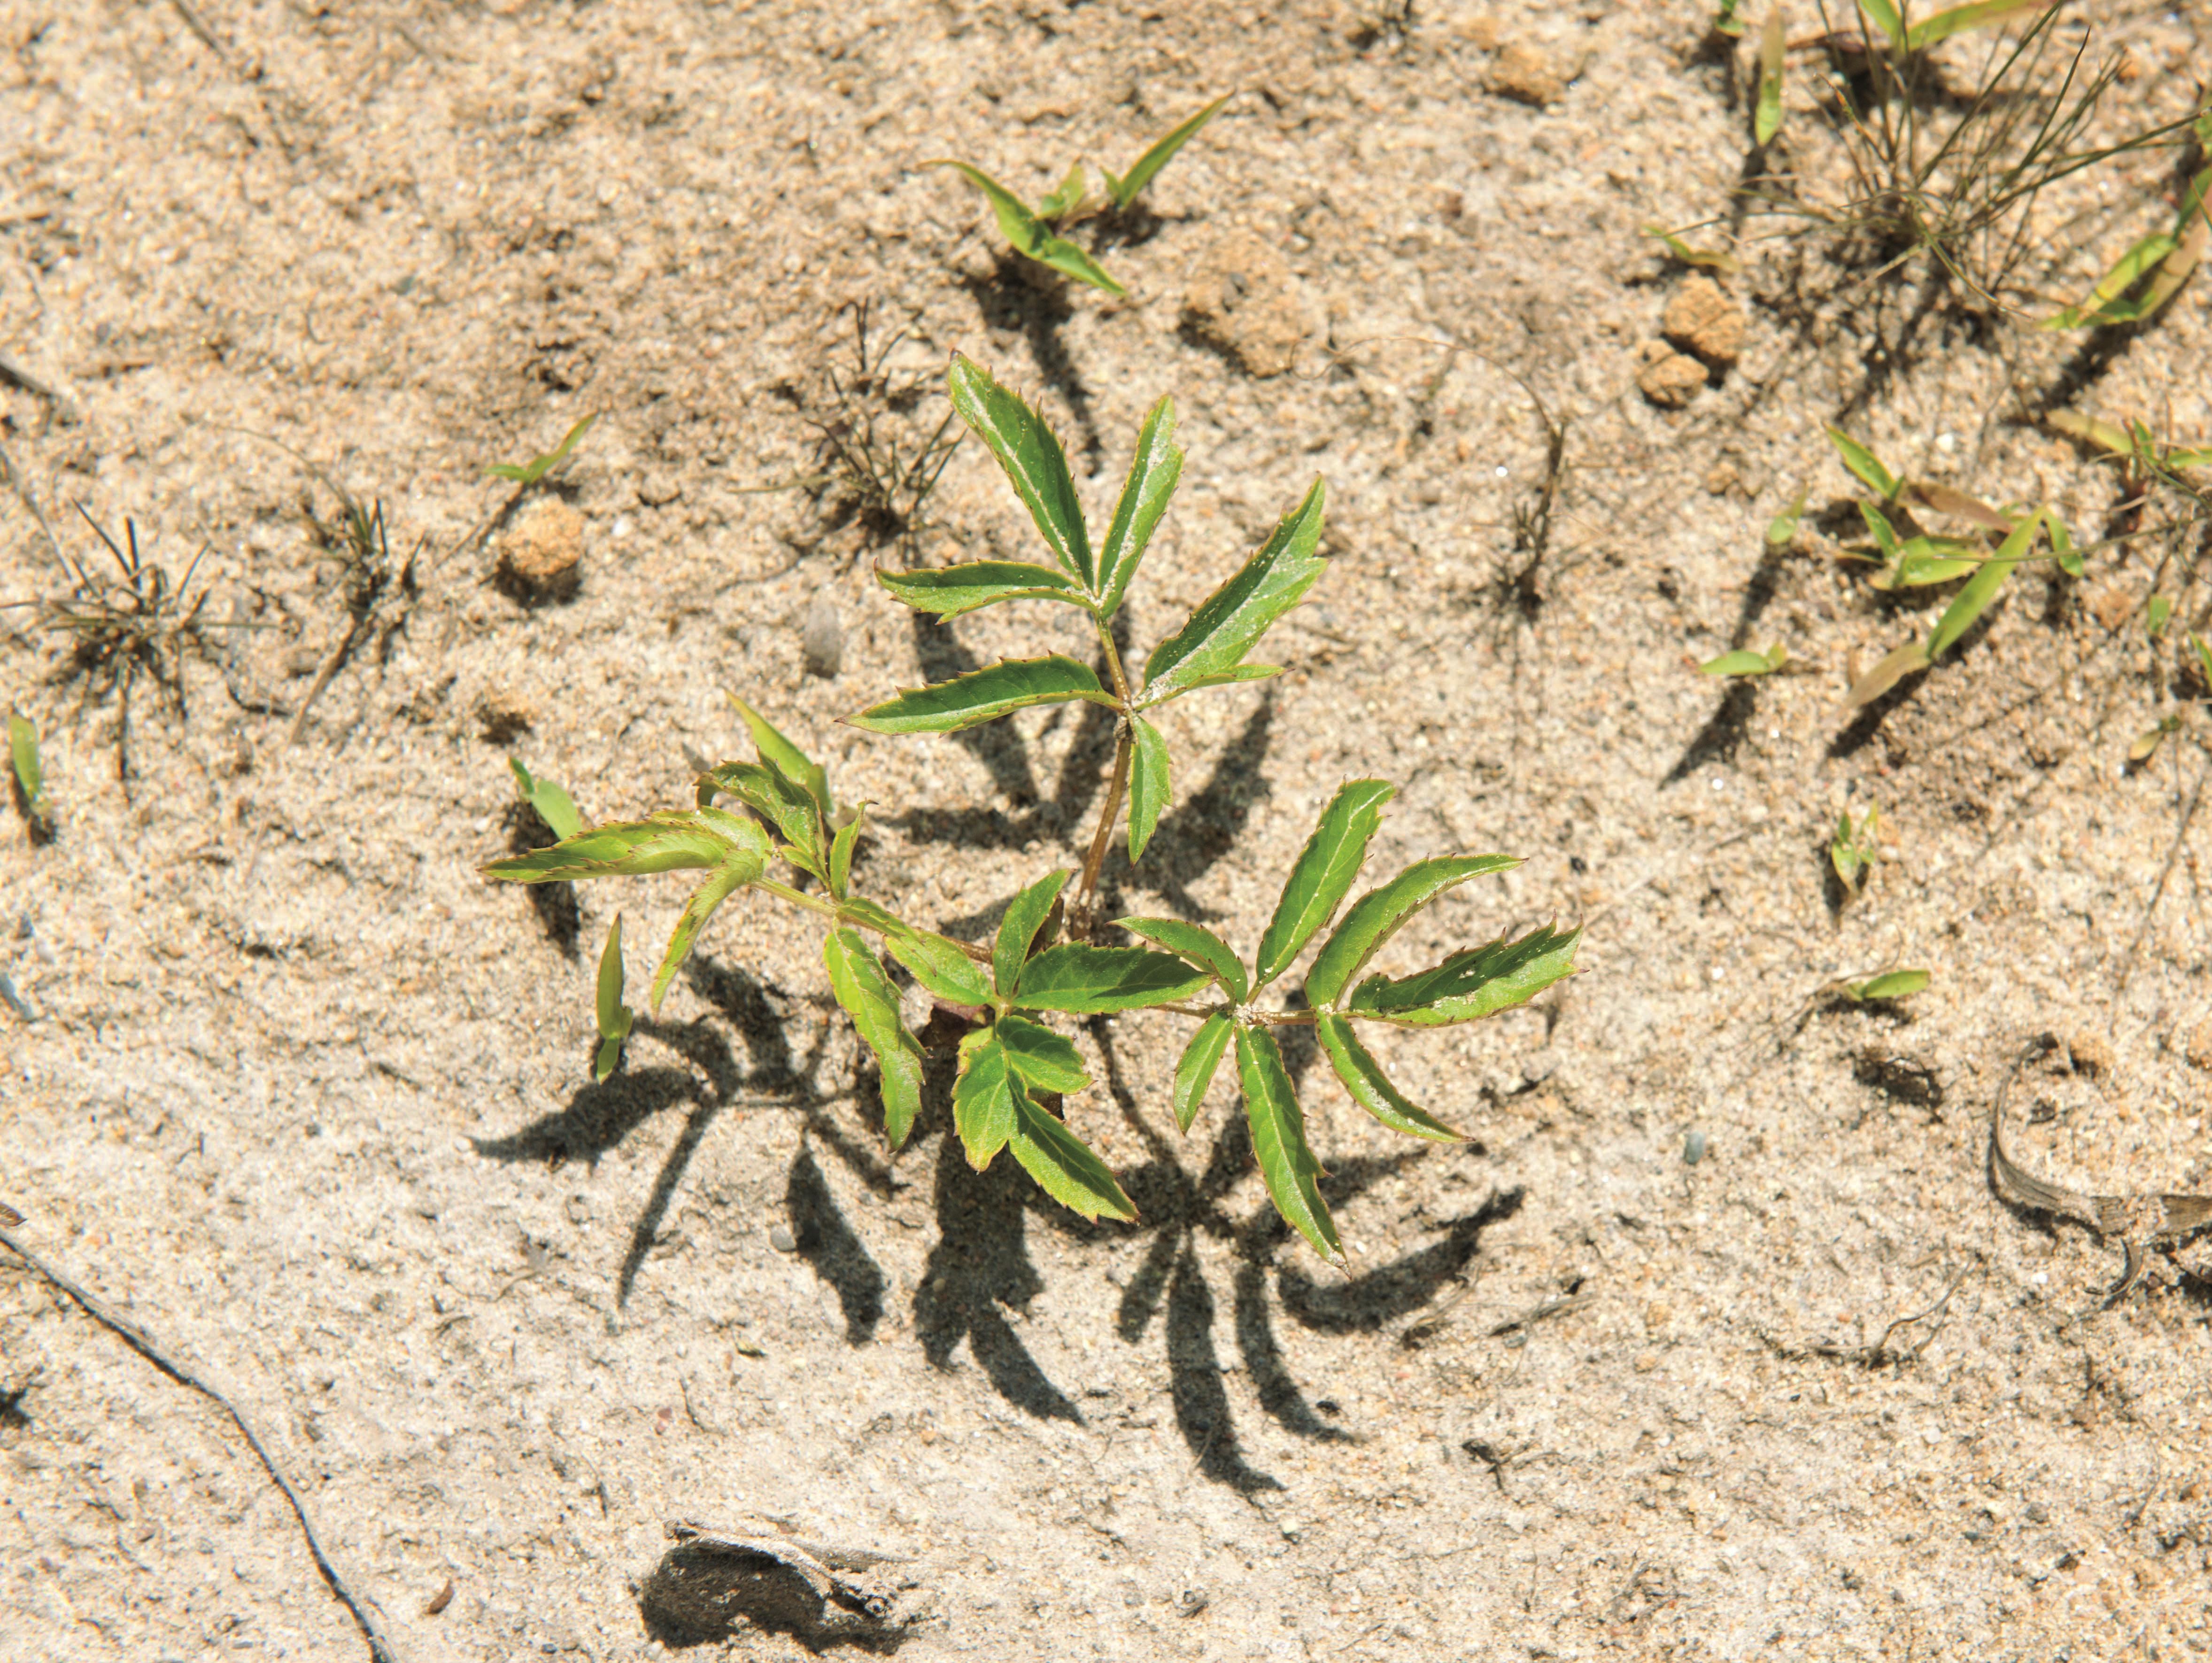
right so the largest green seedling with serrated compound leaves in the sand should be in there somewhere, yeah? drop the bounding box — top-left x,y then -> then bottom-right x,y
487,358 -> 1582,1265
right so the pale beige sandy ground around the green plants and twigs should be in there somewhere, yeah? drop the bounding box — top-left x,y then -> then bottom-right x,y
0,0 -> 2212,1663
